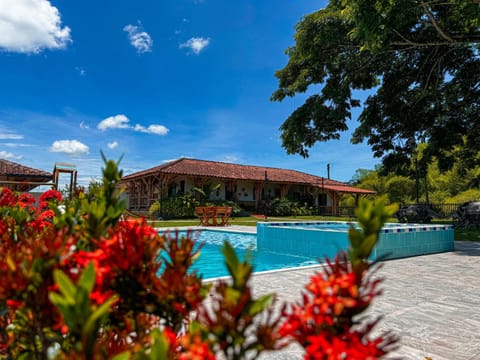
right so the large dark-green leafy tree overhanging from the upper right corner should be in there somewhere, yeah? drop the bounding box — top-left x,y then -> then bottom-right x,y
271,0 -> 480,170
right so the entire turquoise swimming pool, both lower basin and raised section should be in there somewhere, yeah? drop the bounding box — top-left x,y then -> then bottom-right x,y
162,221 -> 454,279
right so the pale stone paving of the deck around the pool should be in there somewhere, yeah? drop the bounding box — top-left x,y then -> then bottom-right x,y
161,226 -> 480,360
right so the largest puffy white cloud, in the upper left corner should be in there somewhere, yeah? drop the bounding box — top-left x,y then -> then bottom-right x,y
0,0 -> 71,53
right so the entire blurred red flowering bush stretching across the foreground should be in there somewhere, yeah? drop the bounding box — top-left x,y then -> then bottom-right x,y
0,160 -> 395,360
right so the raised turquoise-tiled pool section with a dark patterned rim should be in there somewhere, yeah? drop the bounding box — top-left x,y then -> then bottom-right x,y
257,221 -> 454,260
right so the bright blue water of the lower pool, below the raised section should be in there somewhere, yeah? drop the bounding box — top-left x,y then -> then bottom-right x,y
162,230 -> 318,279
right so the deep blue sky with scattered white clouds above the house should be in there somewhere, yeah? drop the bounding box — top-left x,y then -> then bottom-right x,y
0,0 -> 378,184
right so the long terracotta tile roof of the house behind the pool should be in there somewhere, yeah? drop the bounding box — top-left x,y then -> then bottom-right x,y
122,158 -> 374,194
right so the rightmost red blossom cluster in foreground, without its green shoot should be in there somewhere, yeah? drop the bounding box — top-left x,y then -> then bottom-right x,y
280,254 -> 395,359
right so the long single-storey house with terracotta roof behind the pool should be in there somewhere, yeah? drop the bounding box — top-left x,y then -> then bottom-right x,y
120,158 -> 374,214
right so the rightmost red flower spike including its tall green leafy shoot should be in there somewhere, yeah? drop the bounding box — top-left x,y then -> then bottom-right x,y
280,202 -> 397,359
